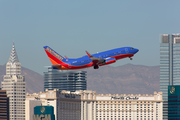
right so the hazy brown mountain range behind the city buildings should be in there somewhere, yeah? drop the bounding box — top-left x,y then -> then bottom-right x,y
0,64 -> 160,94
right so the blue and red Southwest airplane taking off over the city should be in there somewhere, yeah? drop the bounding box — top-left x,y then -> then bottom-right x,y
44,46 -> 139,70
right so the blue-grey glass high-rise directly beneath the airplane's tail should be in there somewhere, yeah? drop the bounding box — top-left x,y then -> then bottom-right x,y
44,68 -> 87,92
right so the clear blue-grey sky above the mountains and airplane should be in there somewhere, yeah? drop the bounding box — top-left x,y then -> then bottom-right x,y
0,0 -> 180,74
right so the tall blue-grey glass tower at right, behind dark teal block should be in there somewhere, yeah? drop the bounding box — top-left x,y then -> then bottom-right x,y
160,34 -> 180,120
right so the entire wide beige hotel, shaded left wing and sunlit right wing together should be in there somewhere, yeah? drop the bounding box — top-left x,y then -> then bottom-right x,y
26,89 -> 163,120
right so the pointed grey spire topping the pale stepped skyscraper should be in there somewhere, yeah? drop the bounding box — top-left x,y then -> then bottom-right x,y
8,42 -> 19,64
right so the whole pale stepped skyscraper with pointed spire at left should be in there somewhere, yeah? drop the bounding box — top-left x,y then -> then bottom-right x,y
1,43 -> 26,120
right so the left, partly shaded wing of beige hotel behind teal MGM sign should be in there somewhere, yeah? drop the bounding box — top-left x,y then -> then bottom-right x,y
26,89 -> 81,120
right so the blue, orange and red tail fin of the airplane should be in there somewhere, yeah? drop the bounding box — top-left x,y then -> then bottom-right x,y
44,46 -> 66,65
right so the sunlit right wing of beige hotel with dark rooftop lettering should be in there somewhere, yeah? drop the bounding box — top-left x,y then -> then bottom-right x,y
80,91 -> 163,120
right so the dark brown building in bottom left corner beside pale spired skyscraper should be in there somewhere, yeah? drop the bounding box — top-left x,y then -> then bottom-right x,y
0,90 -> 9,120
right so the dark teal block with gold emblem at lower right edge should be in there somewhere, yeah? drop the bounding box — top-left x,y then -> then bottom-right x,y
168,85 -> 180,120
